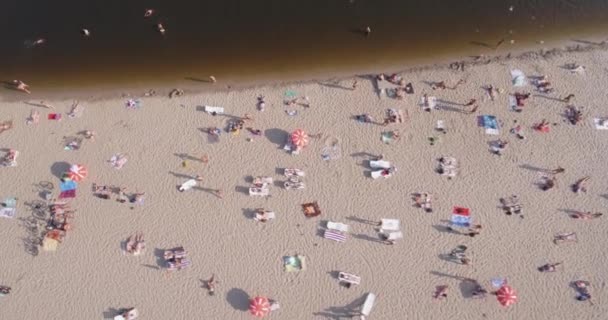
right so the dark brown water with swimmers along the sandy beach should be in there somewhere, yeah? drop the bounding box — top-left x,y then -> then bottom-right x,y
0,0 -> 608,88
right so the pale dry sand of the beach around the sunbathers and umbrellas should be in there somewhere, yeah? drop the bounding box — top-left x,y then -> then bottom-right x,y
0,43 -> 608,320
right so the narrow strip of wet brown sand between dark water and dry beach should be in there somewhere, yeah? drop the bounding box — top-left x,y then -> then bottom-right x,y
0,33 -> 608,102
